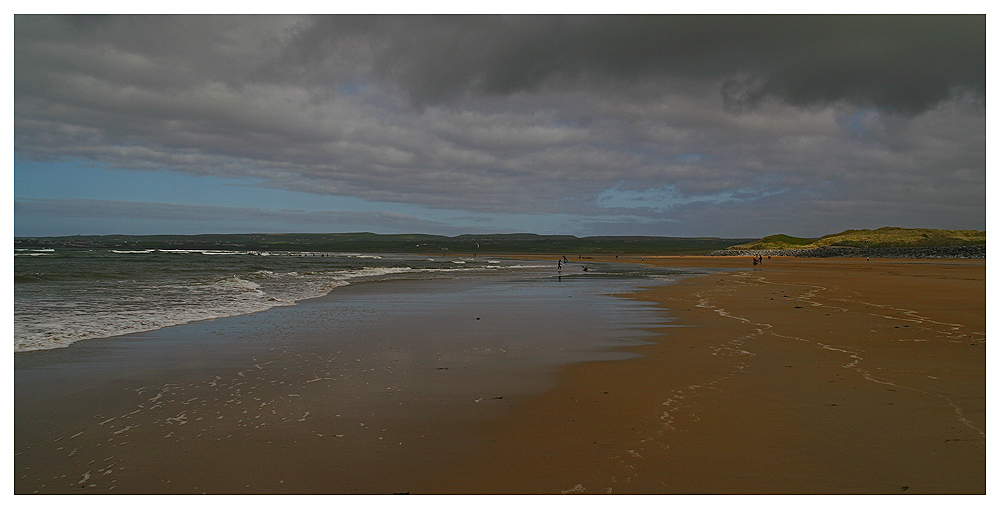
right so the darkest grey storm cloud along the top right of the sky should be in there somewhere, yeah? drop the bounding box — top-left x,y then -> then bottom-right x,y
287,15 -> 986,113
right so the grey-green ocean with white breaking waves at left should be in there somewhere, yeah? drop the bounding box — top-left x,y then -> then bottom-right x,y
14,248 -> 700,352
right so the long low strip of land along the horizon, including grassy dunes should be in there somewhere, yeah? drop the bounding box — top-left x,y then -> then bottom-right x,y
14,227 -> 986,258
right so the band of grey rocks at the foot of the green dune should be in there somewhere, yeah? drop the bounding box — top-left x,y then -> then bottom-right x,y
708,244 -> 986,259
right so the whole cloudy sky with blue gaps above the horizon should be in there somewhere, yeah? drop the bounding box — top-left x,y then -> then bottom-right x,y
14,15 -> 986,237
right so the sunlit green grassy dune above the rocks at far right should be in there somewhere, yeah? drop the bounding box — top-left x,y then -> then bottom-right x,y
729,226 -> 986,249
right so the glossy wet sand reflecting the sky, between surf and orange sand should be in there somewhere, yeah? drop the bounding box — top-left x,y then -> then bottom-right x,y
14,271 -> 662,494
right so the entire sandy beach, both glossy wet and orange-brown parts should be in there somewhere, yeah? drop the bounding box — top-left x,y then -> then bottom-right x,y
14,256 -> 986,494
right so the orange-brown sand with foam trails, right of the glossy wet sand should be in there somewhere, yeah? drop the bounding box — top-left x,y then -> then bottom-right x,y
428,257 -> 986,494
